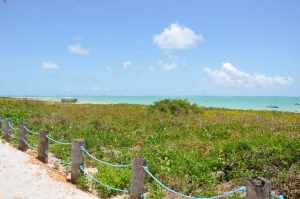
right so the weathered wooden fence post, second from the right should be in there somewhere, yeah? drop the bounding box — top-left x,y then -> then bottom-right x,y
129,157 -> 146,199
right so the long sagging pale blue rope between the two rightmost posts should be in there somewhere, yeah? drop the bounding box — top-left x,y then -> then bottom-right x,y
143,166 -> 247,199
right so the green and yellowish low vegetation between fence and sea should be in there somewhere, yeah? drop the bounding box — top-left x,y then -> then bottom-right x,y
0,98 -> 300,198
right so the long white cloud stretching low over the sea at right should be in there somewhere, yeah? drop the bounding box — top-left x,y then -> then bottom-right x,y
204,63 -> 294,88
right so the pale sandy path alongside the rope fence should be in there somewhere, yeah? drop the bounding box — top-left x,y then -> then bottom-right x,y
0,140 -> 98,199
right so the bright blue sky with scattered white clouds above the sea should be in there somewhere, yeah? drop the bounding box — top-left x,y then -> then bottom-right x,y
0,0 -> 300,96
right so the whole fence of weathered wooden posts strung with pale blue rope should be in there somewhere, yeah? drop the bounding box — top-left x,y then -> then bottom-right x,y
0,118 -> 284,199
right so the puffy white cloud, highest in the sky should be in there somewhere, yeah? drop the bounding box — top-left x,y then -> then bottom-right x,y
153,23 -> 204,49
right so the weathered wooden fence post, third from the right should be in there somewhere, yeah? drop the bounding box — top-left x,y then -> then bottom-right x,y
71,139 -> 84,183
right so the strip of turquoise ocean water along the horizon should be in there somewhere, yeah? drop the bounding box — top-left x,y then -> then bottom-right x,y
22,96 -> 300,112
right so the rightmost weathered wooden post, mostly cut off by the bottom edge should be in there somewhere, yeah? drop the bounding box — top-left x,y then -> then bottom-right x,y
246,177 -> 271,199
